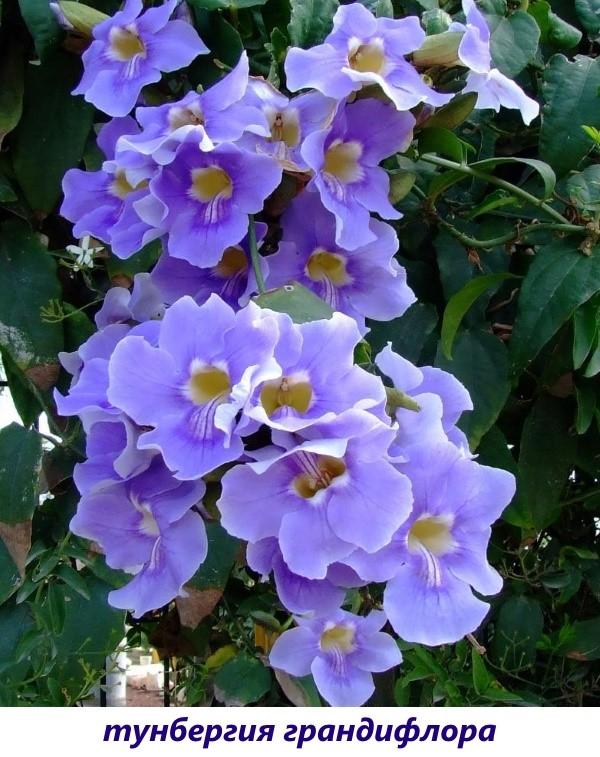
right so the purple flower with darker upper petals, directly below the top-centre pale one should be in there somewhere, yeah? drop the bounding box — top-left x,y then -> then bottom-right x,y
301,100 -> 415,250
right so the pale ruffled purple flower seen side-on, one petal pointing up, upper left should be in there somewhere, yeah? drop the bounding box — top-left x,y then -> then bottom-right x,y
119,51 -> 269,165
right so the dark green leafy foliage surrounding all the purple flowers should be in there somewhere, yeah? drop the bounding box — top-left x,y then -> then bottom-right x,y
0,0 -> 600,705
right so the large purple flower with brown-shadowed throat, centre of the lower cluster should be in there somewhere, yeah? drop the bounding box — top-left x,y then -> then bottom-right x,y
218,410 -> 411,579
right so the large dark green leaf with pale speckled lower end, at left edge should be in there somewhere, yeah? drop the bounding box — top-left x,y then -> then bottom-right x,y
0,221 -> 63,372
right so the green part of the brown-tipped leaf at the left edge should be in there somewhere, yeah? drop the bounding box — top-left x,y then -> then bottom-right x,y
0,423 -> 42,524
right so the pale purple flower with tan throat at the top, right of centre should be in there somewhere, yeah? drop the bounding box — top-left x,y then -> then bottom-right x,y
285,3 -> 451,111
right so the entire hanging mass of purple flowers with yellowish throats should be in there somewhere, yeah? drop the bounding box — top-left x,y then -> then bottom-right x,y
56,0 -> 524,705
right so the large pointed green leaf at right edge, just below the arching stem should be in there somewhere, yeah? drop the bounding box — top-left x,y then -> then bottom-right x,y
510,239 -> 600,376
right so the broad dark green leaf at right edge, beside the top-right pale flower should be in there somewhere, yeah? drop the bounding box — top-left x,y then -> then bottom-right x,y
540,55 -> 600,176
